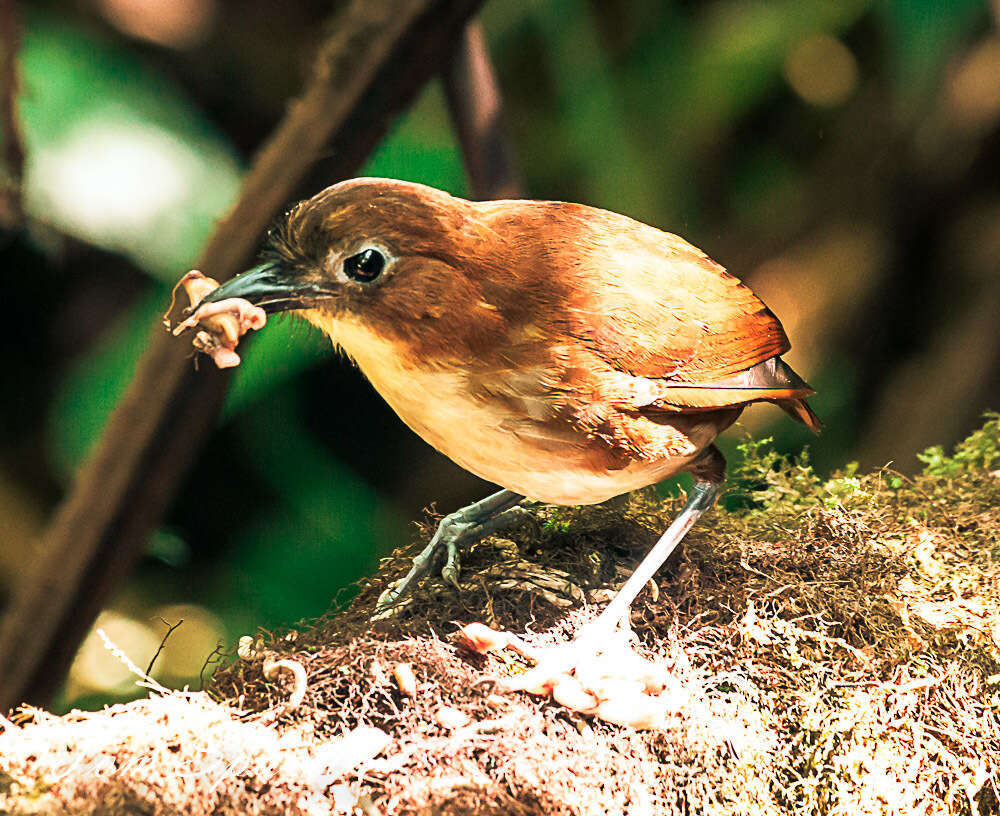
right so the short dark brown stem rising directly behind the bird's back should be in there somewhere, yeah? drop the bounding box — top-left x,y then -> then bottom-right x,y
443,22 -> 523,200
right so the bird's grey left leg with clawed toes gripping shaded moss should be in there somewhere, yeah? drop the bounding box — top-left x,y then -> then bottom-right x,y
374,490 -> 524,618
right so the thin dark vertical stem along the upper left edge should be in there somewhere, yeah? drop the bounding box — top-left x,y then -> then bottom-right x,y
0,0 -> 24,227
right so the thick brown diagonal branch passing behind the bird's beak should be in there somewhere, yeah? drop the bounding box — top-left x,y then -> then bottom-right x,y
0,0 -> 480,710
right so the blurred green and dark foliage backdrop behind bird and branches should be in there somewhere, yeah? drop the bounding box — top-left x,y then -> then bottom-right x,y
0,0 -> 1000,708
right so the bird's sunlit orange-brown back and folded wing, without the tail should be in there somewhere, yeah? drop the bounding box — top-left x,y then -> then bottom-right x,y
488,202 -> 790,383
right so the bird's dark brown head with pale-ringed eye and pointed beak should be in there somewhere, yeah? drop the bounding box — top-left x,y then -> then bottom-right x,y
196,178 -> 516,358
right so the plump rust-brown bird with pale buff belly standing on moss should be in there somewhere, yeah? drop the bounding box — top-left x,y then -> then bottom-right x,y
189,178 -> 820,637
